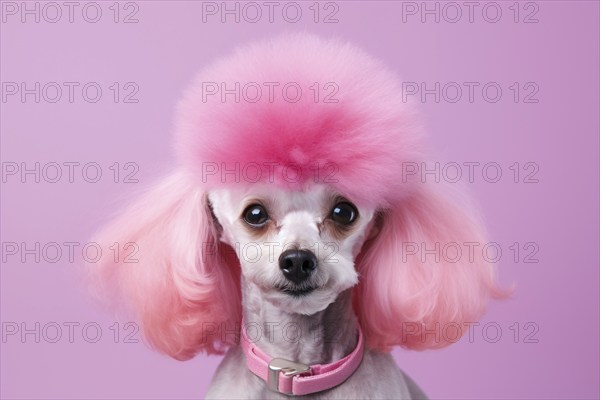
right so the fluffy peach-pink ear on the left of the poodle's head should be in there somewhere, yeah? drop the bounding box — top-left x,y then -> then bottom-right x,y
88,172 -> 241,359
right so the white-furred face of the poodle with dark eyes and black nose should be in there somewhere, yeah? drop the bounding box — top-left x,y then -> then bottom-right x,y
208,184 -> 374,315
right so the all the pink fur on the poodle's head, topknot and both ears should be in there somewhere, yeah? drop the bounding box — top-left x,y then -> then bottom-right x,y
92,33 -> 505,359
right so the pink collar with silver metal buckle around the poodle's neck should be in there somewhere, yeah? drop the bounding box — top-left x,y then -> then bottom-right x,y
240,324 -> 364,395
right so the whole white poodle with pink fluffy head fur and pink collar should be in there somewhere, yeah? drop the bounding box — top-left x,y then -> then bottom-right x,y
93,33 -> 503,399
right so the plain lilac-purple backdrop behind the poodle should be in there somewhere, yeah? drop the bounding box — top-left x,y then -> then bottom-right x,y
1,1 -> 600,399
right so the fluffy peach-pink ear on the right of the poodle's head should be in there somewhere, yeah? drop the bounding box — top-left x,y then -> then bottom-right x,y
354,184 -> 508,351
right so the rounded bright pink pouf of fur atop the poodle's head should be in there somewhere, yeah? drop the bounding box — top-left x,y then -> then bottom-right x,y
176,34 -> 422,206
